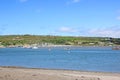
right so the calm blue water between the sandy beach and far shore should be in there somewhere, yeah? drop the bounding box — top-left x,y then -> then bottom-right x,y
0,47 -> 120,73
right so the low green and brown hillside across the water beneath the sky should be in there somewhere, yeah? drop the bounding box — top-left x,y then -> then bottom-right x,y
0,35 -> 120,46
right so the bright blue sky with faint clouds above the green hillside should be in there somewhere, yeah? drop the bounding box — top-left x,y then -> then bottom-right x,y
0,0 -> 120,38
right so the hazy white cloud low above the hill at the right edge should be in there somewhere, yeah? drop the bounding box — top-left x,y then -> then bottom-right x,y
88,26 -> 120,38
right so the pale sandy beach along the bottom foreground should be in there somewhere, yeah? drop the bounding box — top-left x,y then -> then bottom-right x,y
0,66 -> 120,80
